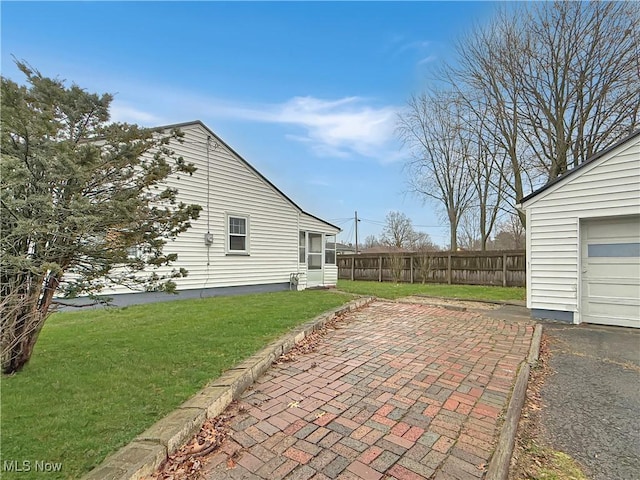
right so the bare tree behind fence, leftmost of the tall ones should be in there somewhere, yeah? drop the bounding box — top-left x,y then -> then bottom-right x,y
398,92 -> 473,250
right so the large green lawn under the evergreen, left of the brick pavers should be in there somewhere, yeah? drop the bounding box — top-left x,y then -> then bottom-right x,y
0,291 -> 351,479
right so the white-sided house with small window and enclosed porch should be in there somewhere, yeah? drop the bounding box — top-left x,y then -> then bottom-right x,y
91,121 -> 340,305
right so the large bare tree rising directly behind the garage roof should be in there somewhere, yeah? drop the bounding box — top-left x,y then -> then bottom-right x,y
440,2 -> 640,225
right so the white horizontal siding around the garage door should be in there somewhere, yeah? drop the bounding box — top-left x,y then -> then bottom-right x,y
522,136 -> 640,323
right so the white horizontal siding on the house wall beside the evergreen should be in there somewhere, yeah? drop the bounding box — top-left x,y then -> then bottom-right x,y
100,123 -> 339,294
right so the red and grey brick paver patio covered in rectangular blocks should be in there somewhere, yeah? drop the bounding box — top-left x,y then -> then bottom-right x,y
204,302 -> 533,480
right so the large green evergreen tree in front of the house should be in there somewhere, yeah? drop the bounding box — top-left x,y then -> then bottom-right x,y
0,62 -> 200,373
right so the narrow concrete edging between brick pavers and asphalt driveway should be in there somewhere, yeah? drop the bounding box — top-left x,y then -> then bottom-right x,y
484,324 -> 542,480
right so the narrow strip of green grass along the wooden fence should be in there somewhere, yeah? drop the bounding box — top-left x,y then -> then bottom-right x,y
338,280 -> 526,302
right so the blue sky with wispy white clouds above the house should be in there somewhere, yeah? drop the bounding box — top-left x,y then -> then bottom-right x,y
0,1 -> 496,245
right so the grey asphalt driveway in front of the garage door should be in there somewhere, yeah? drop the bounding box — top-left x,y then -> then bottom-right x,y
541,324 -> 640,480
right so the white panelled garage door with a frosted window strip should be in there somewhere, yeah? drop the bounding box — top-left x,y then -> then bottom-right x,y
581,216 -> 640,328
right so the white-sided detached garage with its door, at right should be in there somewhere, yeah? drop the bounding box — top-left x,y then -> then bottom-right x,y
520,131 -> 640,328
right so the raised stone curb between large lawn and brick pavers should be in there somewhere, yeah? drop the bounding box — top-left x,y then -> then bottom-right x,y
82,297 -> 375,480
